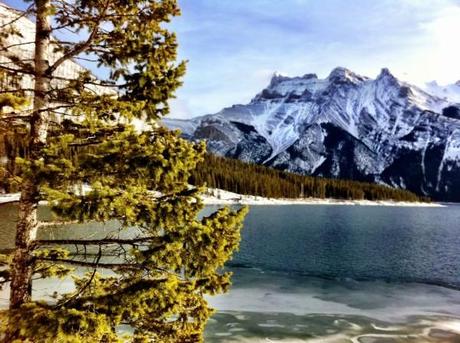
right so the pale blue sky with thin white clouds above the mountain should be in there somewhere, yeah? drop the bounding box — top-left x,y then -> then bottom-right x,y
6,0 -> 460,118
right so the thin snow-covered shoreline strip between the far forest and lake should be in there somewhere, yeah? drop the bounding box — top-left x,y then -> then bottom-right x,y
0,189 -> 446,207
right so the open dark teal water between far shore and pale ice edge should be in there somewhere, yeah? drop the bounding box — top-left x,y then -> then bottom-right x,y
228,205 -> 460,288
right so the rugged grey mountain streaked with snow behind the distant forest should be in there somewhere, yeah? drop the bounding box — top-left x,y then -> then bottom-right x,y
165,68 -> 460,201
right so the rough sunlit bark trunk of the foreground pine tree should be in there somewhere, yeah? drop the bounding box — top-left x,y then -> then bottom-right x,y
10,0 -> 51,309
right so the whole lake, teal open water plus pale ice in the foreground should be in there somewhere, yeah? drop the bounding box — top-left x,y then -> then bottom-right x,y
0,204 -> 460,343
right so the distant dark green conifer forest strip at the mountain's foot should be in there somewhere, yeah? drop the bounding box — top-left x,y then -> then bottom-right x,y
190,153 -> 429,201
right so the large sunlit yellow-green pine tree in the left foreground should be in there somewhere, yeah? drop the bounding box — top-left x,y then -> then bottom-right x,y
0,0 -> 246,342
